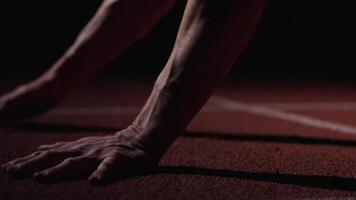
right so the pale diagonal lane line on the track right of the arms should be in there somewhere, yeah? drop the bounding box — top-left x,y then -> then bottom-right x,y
212,96 -> 356,135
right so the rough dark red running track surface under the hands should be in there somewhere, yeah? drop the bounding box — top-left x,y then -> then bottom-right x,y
0,76 -> 356,199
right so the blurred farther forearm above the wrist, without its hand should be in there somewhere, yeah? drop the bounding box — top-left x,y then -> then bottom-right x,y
41,0 -> 175,90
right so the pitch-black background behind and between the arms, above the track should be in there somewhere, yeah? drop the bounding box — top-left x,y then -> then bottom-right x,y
0,0 -> 356,79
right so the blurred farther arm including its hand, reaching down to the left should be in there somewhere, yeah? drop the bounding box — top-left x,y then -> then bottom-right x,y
0,0 -> 175,120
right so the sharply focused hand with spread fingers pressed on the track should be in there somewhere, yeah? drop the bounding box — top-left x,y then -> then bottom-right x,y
2,128 -> 159,184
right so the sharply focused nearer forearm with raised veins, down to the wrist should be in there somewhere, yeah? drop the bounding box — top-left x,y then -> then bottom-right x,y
133,0 -> 266,155
